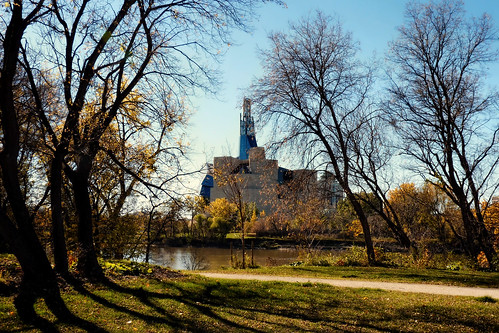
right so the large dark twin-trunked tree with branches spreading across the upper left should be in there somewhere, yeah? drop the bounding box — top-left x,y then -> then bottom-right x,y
10,0 -> 278,278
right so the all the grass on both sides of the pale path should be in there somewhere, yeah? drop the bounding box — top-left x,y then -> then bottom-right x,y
0,252 -> 499,332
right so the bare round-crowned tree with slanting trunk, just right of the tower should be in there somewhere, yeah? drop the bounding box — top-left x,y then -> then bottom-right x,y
253,13 -> 376,264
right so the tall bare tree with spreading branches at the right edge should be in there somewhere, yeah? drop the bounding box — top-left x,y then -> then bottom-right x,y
385,0 -> 499,265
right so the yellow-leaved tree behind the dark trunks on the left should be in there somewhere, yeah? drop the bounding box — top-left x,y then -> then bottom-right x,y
90,90 -> 186,257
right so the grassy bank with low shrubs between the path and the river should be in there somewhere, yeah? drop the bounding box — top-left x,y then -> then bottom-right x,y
209,247 -> 499,288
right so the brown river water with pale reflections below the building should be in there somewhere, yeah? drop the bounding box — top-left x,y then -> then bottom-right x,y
150,247 -> 298,270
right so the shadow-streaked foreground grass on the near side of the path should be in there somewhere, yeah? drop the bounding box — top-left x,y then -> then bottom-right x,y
0,276 -> 499,332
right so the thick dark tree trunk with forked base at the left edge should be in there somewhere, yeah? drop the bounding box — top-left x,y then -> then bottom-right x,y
0,0 -> 71,321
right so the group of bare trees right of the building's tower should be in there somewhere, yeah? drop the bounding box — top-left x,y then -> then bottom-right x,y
252,0 -> 499,268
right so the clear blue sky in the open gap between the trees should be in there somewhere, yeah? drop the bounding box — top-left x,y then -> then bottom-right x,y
187,0 -> 499,190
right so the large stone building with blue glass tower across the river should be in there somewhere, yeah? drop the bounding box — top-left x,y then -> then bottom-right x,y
200,98 -> 343,212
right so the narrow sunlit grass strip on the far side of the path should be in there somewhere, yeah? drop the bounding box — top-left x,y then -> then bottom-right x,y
209,265 -> 499,288
